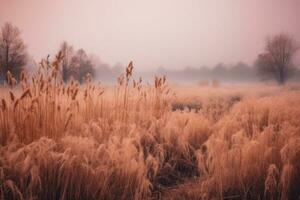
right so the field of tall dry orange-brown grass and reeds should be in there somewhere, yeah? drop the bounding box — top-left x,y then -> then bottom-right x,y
0,61 -> 300,200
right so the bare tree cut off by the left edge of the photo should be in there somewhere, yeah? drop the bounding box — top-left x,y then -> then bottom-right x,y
0,23 -> 27,80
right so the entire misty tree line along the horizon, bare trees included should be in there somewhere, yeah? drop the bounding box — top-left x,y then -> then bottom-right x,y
0,23 -> 299,85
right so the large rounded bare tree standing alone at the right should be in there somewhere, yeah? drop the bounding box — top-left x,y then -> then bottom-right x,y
255,33 -> 298,84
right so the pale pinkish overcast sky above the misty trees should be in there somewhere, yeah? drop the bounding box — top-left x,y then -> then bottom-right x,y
0,0 -> 300,69
